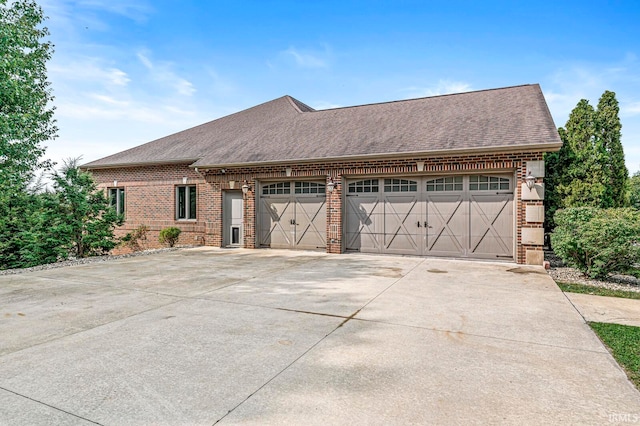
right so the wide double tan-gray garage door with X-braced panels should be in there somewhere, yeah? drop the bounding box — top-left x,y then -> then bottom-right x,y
345,175 -> 514,259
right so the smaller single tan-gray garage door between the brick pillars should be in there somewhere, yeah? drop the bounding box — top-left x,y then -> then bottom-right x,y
258,181 -> 327,250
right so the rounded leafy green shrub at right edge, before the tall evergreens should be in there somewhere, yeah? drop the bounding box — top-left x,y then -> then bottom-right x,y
551,207 -> 640,278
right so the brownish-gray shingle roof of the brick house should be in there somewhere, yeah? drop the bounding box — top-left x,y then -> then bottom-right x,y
83,84 -> 561,168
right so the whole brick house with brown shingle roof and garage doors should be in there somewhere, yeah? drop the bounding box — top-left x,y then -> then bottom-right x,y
82,84 -> 562,264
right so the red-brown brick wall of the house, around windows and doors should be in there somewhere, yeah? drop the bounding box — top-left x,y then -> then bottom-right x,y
92,152 -> 543,263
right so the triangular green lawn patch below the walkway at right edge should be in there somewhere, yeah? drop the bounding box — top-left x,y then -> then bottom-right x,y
589,322 -> 640,389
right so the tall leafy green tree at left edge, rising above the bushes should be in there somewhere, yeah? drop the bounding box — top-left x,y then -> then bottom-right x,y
0,0 -> 57,190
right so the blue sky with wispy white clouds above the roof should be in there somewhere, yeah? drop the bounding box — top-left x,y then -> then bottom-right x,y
39,0 -> 640,172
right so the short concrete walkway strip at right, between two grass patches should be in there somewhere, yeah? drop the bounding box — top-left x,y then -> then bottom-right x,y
565,293 -> 640,326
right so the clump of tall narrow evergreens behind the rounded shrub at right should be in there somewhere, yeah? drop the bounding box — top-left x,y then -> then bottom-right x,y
545,91 -> 628,231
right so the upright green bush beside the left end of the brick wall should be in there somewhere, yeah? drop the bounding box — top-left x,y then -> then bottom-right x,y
53,159 -> 124,257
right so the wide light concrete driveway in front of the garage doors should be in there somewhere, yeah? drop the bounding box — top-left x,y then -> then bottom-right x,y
0,248 -> 640,425
